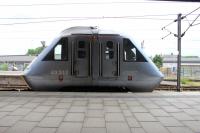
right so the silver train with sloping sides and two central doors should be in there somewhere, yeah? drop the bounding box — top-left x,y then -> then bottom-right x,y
24,27 -> 163,92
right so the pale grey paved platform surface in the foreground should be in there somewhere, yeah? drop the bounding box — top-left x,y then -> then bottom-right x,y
0,91 -> 200,133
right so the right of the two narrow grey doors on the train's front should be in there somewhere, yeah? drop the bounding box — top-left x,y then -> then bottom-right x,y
99,35 -> 120,78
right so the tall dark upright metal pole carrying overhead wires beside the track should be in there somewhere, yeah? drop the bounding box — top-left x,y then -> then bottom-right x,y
177,14 -> 181,91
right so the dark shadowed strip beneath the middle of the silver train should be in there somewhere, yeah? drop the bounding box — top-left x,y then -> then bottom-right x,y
59,86 -> 129,93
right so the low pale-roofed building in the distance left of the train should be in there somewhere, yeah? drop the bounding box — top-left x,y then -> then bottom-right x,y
0,55 -> 35,71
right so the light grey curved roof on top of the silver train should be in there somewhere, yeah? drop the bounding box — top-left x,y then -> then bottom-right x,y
61,26 -> 120,36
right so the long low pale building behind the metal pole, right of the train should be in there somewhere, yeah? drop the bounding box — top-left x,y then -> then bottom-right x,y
163,55 -> 200,77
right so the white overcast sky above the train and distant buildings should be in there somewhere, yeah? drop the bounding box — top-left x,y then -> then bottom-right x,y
0,0 -> 200,56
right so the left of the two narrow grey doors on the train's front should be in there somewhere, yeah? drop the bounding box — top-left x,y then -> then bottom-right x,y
72,36 -> 91,77
